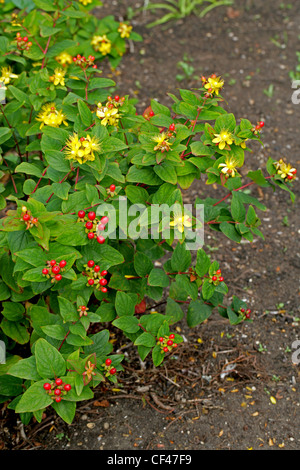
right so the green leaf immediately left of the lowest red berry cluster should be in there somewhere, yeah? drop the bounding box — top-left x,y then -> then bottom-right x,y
15,380 -> 53,413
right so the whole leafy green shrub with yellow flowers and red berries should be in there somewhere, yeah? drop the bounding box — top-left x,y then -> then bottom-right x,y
0,0 -> 296,424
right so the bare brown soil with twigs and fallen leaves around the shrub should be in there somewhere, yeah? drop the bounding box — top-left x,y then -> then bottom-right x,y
1,0 -> 300,450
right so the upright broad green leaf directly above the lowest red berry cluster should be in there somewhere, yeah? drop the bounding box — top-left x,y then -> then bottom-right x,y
34,338 -> 66,379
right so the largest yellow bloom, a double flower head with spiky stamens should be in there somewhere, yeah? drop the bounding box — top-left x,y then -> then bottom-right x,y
65,133 -> 100,165
